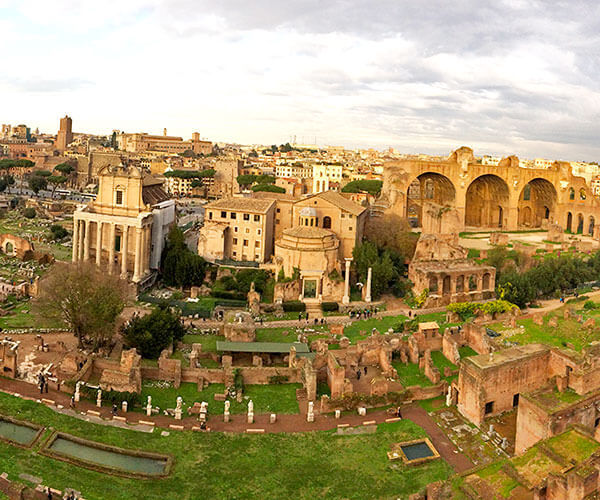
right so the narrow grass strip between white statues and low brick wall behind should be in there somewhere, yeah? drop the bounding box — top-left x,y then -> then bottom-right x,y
139,382 -> 301,415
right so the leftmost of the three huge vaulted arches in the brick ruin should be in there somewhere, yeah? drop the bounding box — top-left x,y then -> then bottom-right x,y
406,172 -> 456,227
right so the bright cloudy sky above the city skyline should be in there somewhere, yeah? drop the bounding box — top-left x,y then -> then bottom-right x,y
0,0 -> 600,160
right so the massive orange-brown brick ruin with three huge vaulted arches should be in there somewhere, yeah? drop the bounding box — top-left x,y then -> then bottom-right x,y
380,147 -> 600,237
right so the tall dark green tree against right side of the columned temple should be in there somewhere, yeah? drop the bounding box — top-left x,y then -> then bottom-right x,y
161,226 -> 206,287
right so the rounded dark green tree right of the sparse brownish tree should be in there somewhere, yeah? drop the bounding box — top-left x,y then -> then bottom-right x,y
122,304 -> 186,359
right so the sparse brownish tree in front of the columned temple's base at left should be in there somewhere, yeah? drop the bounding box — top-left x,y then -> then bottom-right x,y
34,263 -> 129,351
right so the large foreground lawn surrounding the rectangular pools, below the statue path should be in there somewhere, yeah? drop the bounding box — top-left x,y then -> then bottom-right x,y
0,394 -> 452,500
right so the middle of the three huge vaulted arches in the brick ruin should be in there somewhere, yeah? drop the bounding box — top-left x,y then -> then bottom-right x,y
465,174 -> 509,227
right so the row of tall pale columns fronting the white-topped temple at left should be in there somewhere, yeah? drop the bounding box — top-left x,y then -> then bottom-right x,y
72,219 -> 151,282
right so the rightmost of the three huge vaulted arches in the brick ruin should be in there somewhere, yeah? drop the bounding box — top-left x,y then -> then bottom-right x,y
518,178 -> 558,228
